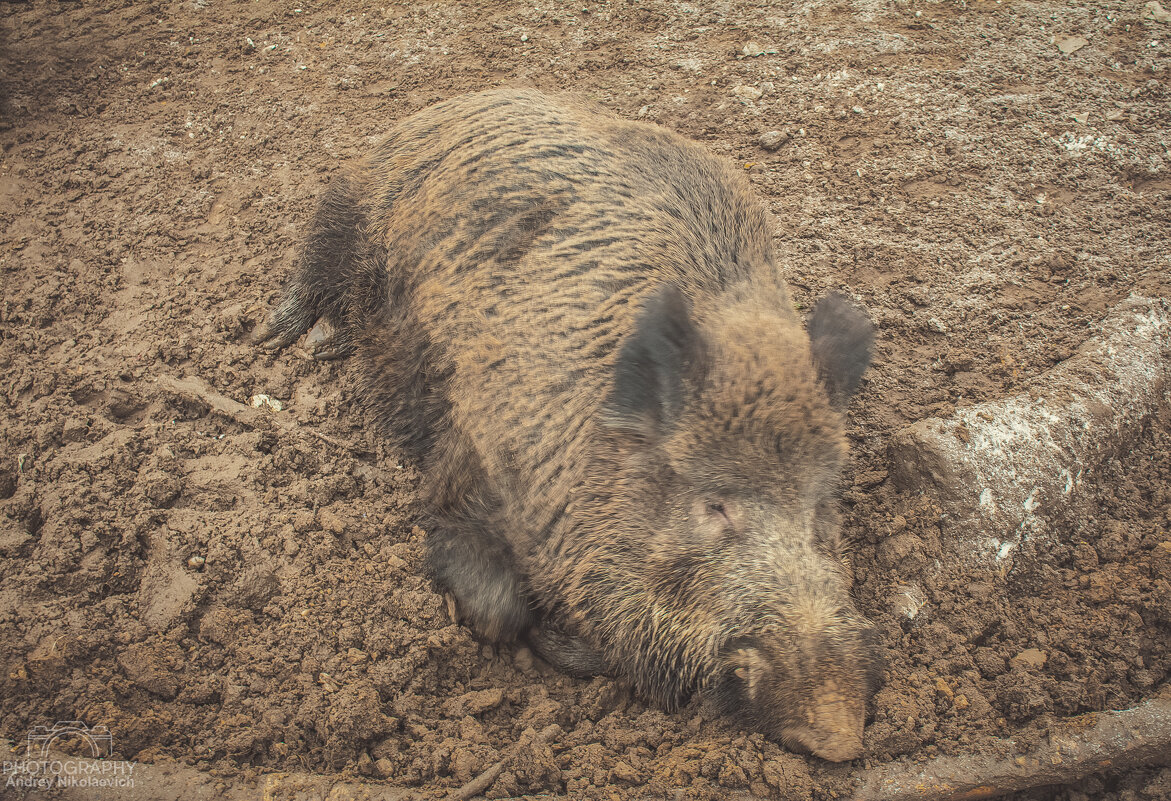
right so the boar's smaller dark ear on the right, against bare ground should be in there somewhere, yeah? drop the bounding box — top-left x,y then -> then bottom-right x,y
809,292 -> 875,406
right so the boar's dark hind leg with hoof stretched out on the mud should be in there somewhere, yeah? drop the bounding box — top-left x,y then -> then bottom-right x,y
252,174 -> 368,358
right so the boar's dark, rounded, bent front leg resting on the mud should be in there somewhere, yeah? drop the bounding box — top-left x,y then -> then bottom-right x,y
427,525 -> 533,642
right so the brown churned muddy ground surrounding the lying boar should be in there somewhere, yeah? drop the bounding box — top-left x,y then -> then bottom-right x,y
0,0 -> 1171,801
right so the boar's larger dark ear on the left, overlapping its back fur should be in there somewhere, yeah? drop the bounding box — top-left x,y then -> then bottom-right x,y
603,285 -> 703,439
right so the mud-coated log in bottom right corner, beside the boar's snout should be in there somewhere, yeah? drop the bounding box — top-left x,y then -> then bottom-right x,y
851,687 -> 1171,801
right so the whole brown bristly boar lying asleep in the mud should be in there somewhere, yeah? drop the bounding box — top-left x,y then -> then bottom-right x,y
256,90 -> 881,759
